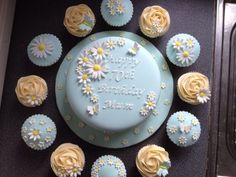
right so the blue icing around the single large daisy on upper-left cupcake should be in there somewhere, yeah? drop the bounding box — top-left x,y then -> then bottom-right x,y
27,34 -> 62,66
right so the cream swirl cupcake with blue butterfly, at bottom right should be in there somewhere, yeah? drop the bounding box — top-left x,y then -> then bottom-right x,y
136,145 -> 171,177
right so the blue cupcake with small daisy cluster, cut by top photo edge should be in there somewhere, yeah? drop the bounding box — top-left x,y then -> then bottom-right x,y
101,0 -> 133,27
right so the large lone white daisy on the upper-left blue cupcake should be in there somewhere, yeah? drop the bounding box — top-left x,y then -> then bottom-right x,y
30,37 -> 53,58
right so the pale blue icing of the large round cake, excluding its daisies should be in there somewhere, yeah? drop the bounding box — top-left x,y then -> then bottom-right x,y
66,37 -> 161,132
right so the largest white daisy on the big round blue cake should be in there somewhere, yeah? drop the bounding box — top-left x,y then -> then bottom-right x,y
87,59 -> 108,80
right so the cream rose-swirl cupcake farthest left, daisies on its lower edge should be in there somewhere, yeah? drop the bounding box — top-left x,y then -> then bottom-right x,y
15,75 -> 48,107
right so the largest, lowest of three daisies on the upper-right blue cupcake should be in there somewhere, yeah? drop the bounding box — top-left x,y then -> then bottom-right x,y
176,48 -> 194,64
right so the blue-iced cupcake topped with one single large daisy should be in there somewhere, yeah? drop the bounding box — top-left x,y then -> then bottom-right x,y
27,34 -> 62,67
